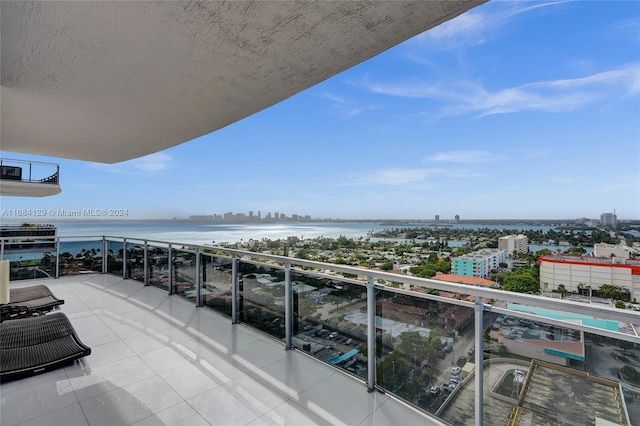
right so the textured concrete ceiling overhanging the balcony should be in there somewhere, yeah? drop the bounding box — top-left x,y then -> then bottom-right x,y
0,0 -> 485,163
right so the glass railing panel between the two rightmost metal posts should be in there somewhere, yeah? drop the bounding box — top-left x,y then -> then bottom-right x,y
376,290 -> 474,424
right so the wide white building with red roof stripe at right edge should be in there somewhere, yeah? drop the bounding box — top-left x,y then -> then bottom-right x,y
538,255 -> 640,301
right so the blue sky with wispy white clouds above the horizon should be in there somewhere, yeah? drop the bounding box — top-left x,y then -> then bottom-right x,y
1,1 -> 640,223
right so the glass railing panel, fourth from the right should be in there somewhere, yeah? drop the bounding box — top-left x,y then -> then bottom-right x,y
238,261 -> 285,339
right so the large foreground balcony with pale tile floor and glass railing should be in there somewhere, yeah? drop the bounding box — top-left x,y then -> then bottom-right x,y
0,236 -> 640,425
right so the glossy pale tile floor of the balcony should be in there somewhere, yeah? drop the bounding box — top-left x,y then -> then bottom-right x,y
0,274 -> 441,426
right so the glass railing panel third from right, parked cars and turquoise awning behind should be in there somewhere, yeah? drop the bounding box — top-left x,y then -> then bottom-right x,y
291,272 -> 368,379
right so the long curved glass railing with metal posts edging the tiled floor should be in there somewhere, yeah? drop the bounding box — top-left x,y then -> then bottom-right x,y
0,236 -> 640,425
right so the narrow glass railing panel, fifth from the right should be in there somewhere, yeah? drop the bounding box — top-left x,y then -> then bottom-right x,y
201,255 -> 233,317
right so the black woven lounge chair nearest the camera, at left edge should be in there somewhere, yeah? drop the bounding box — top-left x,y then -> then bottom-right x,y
0,312 -> 91,382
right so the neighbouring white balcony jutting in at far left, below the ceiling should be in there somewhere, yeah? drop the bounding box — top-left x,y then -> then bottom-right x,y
0,158 -> 62,197
